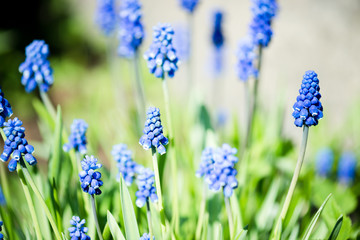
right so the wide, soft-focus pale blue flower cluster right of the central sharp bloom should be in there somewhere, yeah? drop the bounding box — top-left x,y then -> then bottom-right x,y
196,144 -> 238,197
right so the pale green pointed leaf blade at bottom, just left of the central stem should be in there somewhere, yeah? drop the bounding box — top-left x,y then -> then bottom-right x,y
120,177 -> 140,239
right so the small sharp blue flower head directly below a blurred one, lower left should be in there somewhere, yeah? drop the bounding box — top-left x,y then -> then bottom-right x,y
79,156 -> 103,195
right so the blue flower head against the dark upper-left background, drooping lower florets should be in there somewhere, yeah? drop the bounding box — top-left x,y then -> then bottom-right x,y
19,40 -> 54,92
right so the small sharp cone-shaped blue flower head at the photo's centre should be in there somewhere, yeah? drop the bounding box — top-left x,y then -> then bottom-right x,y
139,107 -> 169,155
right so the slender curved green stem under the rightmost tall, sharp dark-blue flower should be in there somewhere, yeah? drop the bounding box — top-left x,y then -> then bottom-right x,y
275,126 -> 309,235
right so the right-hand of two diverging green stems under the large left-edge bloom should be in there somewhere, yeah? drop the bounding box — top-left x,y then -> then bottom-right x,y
20,158 -> 61,240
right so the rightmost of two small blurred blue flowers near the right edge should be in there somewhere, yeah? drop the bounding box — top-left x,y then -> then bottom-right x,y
337,152 -> 357,185
